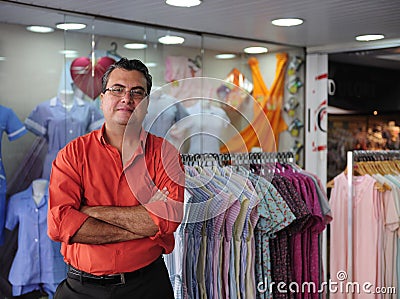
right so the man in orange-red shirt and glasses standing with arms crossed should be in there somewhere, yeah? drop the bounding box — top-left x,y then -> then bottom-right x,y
48,58 -> 184,299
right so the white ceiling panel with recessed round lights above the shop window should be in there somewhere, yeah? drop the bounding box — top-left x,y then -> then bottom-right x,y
7,0 -> 400,47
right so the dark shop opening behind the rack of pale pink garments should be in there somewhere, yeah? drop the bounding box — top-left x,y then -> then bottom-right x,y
327,47 -> 400,181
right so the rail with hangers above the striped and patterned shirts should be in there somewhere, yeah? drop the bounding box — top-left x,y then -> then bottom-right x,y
181,152 -> 295,166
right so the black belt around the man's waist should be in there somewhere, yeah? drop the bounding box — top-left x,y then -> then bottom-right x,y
67,256 -> 162,285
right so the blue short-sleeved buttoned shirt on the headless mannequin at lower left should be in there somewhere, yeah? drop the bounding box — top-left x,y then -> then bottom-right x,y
6,185 -> 66,286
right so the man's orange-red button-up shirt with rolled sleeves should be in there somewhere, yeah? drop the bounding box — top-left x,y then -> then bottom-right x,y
48,126 -> 185,275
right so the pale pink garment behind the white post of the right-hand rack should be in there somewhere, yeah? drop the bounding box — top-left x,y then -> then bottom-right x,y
330,172 -> 382,299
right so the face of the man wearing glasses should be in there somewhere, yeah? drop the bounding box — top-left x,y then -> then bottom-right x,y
100,69 -> 148,126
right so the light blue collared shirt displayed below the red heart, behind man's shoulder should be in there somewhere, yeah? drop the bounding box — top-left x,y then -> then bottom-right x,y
25,97 -> 104,179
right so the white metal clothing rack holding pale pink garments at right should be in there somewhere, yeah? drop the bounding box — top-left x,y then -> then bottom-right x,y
347,150 -> 400,298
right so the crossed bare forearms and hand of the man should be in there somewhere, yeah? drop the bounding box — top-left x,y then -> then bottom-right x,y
70,189 -> 168,244
